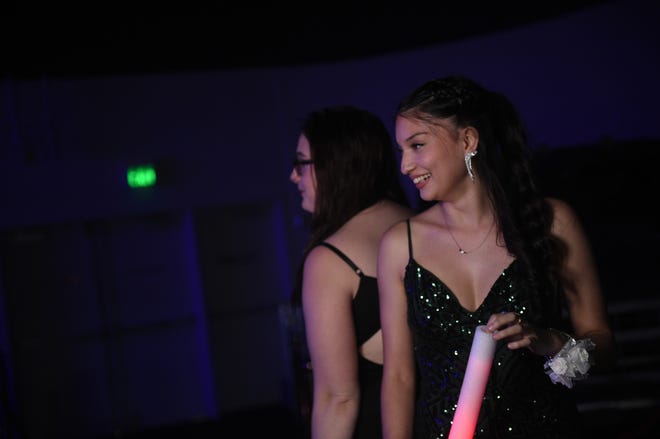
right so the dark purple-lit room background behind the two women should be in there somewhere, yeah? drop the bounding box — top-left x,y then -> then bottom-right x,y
0,1 -> 660,439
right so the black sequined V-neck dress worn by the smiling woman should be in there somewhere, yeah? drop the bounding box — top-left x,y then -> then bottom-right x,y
404,222 -> 581,439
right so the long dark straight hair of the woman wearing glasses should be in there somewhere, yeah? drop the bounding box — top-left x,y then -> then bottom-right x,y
294,105 -> 409,299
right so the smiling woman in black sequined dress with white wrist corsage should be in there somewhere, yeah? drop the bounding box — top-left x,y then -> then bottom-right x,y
378,76 -> 614,439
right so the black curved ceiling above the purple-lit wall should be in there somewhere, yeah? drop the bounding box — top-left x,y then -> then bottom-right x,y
0,0 -> 606,79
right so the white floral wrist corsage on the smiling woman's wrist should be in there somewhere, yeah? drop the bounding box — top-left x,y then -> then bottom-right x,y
544,333 -> 596,388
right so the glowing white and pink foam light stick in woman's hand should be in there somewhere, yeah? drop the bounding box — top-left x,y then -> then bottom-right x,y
449,325 -> 495,439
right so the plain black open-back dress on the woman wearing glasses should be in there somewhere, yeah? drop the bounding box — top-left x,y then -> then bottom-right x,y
322,242 -> 383,439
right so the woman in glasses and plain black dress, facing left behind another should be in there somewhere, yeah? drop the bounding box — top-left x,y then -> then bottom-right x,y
290,106 -> 411,439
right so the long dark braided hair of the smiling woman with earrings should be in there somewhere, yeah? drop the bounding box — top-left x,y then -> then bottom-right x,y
396,76 -> 566,325
